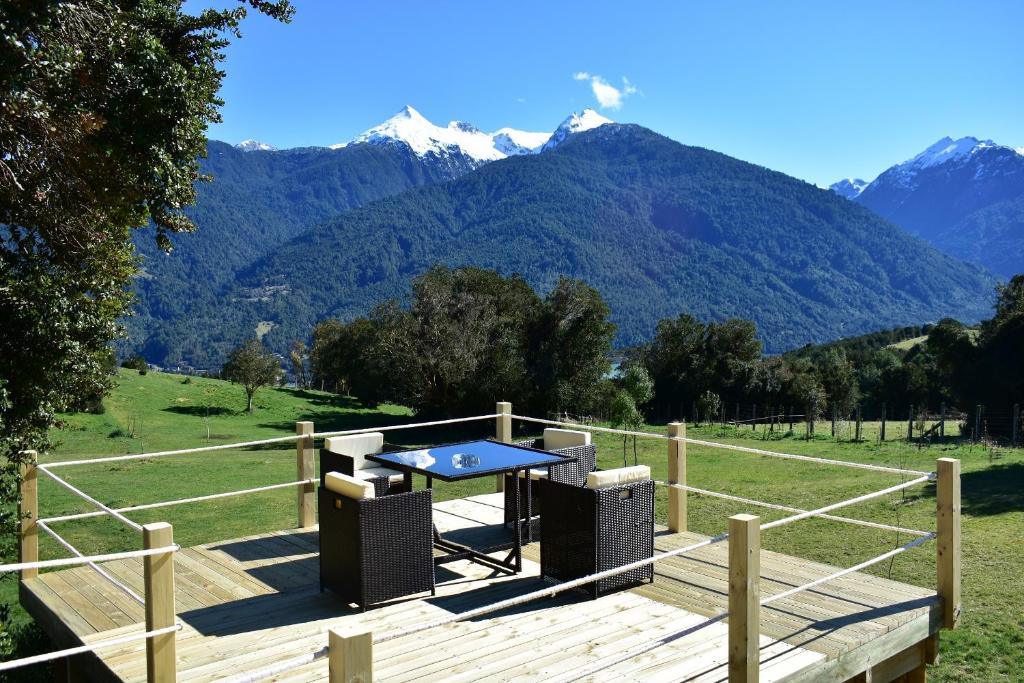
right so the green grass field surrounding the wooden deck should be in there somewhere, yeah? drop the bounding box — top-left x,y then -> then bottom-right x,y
0,371 -> 1024,681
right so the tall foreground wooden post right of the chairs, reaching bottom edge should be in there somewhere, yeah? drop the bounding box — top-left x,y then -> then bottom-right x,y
729,515 -> 761,683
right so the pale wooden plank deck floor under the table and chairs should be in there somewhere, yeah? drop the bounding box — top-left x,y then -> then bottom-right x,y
22,495 -> 941,681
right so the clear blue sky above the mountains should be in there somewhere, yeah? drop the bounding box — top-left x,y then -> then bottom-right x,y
201,0 -> 1024,184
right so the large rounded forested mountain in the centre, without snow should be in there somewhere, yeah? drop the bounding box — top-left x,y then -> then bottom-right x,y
132,124 -> 992,368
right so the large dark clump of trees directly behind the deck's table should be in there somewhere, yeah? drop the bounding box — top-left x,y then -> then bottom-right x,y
312,267 -> 612,415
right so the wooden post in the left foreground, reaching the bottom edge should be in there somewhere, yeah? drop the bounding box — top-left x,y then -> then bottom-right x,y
142,522 -> 177,683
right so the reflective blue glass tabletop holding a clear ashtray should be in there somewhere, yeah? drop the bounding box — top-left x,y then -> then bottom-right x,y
367,440 -> 575,481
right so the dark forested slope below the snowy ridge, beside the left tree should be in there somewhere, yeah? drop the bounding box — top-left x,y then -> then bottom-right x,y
123,140 -> 474,368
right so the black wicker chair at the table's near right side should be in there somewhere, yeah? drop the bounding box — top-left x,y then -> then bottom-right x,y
539,471 -> 654,598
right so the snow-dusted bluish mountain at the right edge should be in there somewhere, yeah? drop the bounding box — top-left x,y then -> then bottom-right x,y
833,137 -> 1024,276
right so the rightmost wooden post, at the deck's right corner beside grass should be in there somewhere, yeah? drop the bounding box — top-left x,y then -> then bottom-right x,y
935,458 -> 961,629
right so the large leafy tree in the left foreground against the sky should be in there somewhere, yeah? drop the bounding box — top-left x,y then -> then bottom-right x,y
0,0 -> 292,647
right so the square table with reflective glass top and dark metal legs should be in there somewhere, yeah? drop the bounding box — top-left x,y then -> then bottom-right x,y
367,439 -> 575,573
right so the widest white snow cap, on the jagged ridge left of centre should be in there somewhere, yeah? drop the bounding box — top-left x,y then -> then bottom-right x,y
331,104 -> 548,164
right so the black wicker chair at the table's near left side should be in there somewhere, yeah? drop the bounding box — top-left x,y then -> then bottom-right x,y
318,479 -> 434,610
